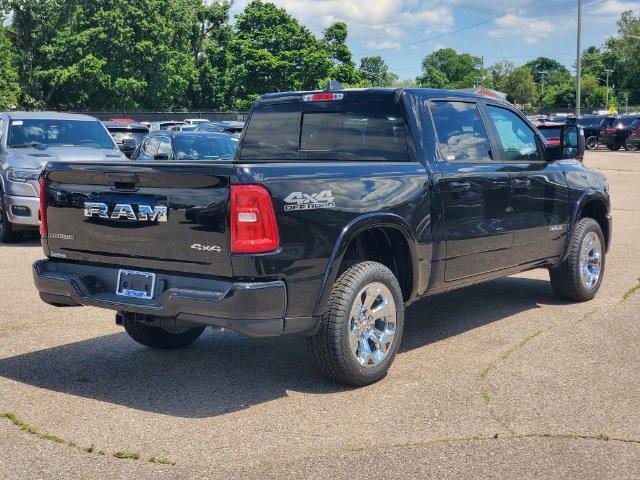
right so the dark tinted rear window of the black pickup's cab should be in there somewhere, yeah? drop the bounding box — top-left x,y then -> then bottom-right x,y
240,102 -> 409,162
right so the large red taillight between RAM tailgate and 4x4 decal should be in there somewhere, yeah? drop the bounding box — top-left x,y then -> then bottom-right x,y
230,185 -> 280,253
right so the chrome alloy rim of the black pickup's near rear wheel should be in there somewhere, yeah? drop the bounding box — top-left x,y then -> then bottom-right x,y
349,282 -> 396,368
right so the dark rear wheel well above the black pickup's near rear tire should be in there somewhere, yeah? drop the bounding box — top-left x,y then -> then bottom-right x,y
338,227 -> 413,301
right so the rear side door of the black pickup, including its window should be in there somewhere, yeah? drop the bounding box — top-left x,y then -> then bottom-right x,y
430,100 -> 513,282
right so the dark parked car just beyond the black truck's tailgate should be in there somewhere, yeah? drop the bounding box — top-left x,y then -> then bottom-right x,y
131,130 -> 238,161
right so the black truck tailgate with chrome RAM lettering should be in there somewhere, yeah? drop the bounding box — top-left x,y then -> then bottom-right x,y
46,162 -> 233,277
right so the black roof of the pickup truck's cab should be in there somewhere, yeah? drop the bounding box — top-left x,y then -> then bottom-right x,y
257,88 -> 508,105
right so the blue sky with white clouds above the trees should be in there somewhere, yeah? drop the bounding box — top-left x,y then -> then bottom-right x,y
233,0 -> 640,78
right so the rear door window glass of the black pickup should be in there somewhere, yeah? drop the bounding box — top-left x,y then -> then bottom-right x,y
430,101 -> 491,163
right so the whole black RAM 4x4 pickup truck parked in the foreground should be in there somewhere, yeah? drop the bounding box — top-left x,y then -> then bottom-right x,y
33,89 -> 611,385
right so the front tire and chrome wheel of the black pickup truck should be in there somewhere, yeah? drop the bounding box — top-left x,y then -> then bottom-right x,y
549,218 -> 605,302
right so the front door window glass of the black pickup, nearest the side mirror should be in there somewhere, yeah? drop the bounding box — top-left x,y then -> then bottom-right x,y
486,105 -> 542,161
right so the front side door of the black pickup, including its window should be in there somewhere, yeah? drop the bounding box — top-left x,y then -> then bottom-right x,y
484,105 -> 571,266
